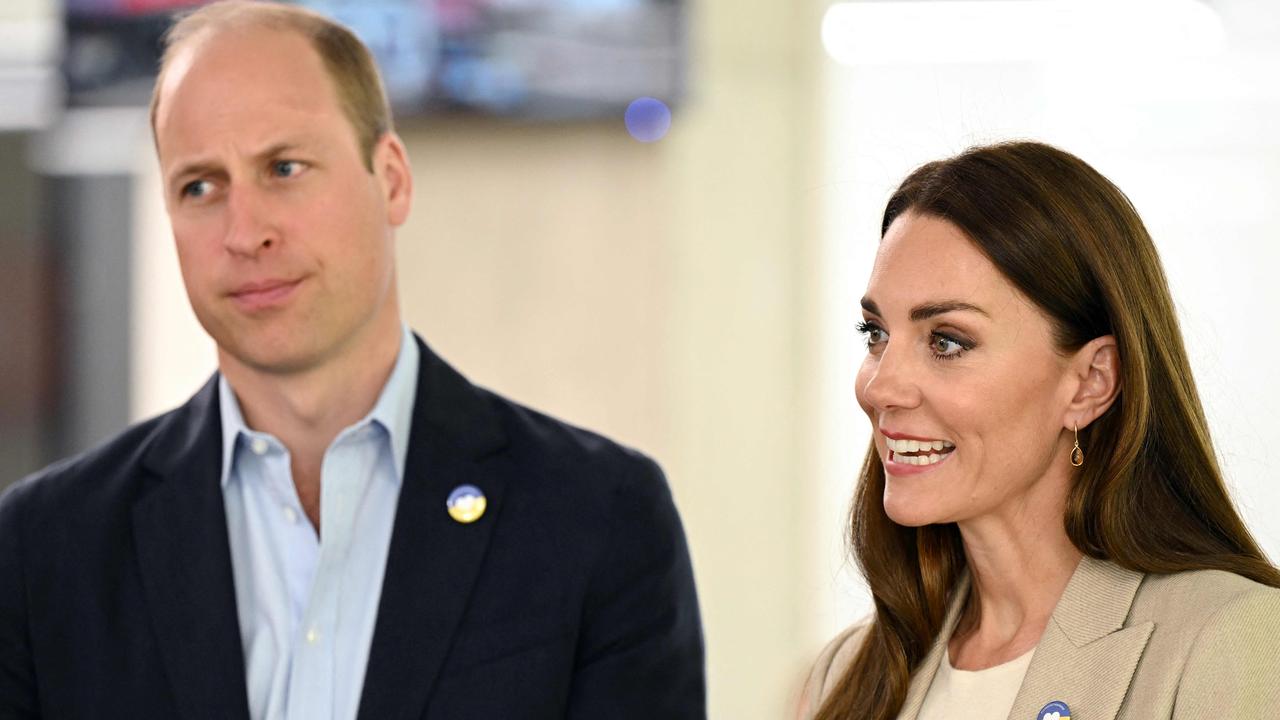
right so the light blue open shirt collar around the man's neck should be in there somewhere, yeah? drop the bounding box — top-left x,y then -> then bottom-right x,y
218,325 -> 421,488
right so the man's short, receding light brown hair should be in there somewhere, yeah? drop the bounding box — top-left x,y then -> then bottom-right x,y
151,0 -> 394,172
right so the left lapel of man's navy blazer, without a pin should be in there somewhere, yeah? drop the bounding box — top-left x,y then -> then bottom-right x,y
133,375 -> 248,720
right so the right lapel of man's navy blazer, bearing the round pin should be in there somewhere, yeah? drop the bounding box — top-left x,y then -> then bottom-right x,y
358,340 -> 507,720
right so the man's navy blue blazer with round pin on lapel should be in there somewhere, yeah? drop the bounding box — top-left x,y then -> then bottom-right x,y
0,340 -> 705,720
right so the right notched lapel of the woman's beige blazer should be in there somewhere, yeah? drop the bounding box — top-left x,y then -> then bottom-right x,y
1003,557 -> 1155,720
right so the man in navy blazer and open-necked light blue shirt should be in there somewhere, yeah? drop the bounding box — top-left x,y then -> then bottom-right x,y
0,3 -> 705,720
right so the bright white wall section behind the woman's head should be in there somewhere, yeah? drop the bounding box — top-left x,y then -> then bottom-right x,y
822,0 -> 1280,635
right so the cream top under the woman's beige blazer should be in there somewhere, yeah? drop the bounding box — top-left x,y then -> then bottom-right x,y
918,640 -> 1036,720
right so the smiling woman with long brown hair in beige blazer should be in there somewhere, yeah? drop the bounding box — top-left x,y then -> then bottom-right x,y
801,142 -> 1280,720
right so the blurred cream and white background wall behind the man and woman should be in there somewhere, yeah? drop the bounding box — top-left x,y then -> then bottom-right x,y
0,0 -> 1280,720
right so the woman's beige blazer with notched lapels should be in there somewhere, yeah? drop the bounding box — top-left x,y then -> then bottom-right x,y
800,557 -> 1280,720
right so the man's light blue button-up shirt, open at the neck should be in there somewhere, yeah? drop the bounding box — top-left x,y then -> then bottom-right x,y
218,327 -> 419,720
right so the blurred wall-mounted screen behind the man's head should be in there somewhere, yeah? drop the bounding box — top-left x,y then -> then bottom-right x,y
63,0 -> 686,120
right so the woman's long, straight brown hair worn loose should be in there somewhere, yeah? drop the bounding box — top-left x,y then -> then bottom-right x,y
815,142 -> 1280,720
